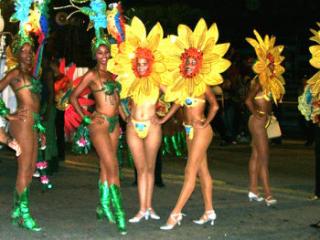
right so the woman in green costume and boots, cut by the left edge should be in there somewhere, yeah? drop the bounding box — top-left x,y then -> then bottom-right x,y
0,0 -> 47,231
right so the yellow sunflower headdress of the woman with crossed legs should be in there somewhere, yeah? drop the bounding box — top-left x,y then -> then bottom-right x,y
161,18 -> 231,104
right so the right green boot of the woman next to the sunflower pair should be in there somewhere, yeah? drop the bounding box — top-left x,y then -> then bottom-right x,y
109,184 -> 127,235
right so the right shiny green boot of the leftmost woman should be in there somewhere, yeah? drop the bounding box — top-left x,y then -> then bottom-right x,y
18,188 -> 41,232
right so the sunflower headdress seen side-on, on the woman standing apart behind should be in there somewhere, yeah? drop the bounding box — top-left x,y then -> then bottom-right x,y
246,30 -> 285,103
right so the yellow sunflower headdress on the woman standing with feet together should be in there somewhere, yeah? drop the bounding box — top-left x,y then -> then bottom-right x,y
108,17 -> 166,105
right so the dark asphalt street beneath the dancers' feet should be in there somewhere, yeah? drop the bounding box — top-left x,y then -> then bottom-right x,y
0,140 -> 320,240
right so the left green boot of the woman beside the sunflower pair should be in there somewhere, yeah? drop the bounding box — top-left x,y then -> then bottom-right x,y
96,181 -> 116,223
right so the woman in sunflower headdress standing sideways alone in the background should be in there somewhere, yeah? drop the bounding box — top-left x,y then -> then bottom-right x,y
245,30 -> 285,206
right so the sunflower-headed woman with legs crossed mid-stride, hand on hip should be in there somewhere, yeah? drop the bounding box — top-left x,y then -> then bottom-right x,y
155,19 -> 230,230
